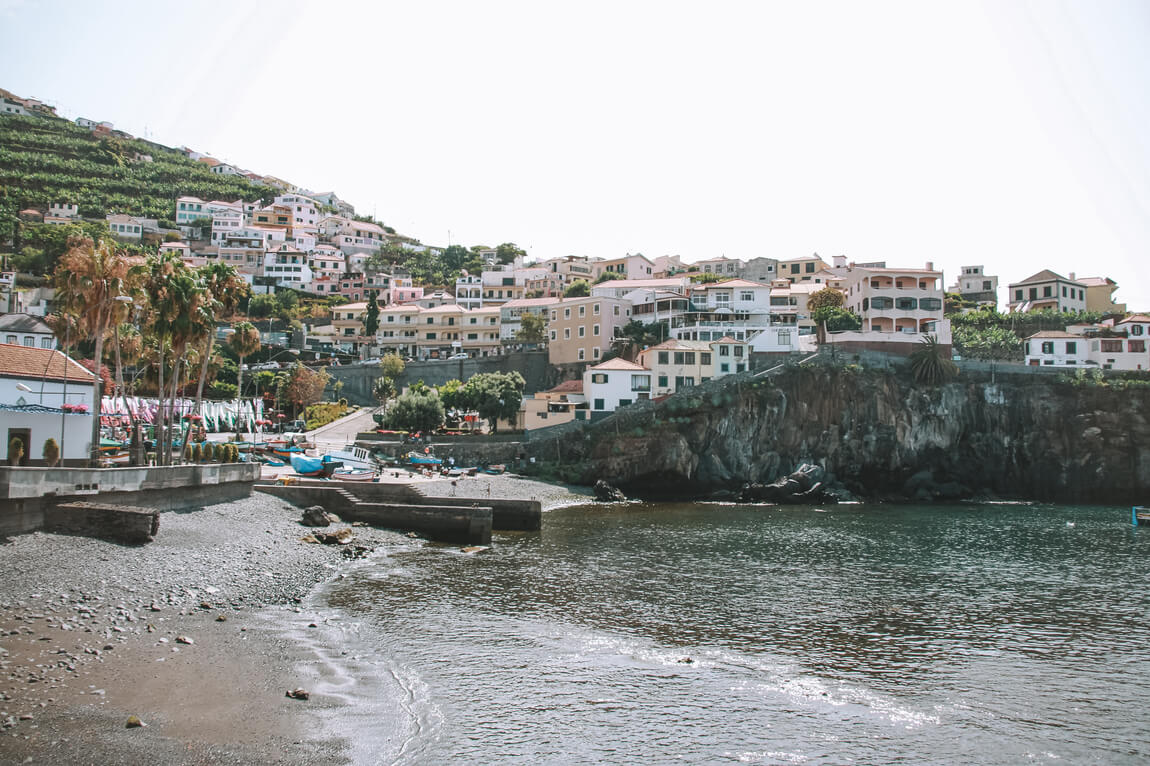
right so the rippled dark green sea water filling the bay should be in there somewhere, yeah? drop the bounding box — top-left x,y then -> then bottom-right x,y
303,504 -> 1150,764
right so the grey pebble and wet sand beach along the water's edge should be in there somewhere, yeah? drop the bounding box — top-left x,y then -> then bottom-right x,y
0,475 -> 593,764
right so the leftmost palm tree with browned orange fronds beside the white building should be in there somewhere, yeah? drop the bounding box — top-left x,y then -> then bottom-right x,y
55,238 -> 129,466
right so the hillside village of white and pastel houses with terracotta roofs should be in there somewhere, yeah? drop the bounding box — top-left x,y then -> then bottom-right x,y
0,86 -> 1150,448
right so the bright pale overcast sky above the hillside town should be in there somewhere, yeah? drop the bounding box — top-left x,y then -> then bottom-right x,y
0,0 -> 1150,309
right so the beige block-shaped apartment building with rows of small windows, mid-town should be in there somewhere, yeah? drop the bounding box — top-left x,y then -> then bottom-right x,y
547,296 -> 631,365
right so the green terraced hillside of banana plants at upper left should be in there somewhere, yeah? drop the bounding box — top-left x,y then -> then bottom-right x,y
0,116 -> 266,221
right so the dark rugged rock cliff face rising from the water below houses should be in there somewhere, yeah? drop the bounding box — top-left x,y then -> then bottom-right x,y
544,368 -> 1150,504
